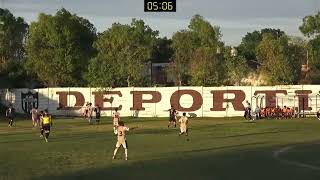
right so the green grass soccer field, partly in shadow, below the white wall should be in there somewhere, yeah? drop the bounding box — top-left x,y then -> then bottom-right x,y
0,118 -> 320,180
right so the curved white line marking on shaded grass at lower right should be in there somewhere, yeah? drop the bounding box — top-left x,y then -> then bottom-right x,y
273,146 -> 320,170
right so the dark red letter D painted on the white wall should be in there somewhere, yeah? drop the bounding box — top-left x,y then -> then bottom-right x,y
56,91 -> 84,110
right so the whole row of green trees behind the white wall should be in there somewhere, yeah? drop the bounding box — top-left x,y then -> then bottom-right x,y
0,9 -> 320,88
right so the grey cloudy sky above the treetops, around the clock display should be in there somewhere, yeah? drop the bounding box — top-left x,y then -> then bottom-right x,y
0,0 -> 320,45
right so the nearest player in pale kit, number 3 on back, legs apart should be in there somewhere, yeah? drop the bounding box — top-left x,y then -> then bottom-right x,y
112,121 -> 129,160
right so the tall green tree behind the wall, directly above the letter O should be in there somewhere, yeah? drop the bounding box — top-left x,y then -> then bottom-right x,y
167,15 -> 224,85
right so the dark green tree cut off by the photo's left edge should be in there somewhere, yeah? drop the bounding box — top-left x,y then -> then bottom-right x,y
0,8 -> 28,87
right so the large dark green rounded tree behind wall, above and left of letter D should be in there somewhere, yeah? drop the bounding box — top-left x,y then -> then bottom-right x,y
26,9 -> 96,86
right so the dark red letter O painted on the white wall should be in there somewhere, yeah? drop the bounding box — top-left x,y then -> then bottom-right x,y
170,90 -> 203,112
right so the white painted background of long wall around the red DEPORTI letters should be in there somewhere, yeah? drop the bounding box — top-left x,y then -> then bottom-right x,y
0,85 -> 320,117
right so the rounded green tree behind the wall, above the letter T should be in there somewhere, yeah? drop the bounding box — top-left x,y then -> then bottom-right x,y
257,33 -> 301,85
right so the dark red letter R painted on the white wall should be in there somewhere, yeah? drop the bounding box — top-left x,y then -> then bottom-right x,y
210,90 -> 246,111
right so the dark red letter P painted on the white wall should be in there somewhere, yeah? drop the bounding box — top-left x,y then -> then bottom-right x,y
130,91 -> 161,111
